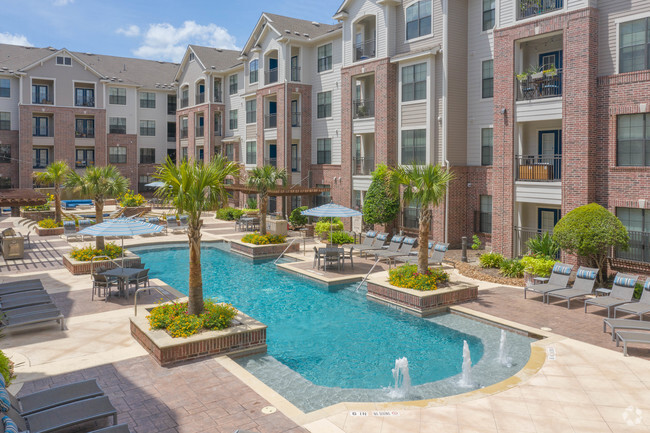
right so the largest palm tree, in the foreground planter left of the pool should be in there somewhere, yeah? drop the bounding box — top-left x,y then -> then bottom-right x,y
154,155 -> 239,314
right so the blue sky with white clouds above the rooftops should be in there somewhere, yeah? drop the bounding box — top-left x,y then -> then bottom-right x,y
0,0 -> 341,61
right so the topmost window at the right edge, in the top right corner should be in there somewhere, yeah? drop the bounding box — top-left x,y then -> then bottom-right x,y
619,18 -> 650,73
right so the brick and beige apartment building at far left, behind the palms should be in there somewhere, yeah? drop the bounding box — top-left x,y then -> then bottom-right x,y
0,45 -> 178,190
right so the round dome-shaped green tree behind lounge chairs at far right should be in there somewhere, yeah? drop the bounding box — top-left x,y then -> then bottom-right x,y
553,203 -> 630,283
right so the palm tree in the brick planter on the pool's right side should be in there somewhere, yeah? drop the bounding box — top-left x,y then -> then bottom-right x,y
395,164 -> 454,273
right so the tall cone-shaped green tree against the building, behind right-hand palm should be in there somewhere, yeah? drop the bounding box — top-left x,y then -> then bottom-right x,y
363,164 -> 399,224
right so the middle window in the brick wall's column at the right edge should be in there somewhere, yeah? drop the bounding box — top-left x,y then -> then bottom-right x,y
616,114 -> 650,166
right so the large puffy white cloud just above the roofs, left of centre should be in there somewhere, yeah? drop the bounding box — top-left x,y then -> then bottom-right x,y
133,21 -> 237,62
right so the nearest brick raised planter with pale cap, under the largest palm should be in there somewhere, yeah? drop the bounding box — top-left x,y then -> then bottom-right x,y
130,311 -> 266,367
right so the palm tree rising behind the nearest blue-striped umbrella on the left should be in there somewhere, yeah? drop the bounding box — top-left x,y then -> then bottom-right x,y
65,165 -> 129,250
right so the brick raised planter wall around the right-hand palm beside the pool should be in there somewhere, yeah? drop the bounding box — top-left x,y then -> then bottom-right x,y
367,279 -> 478,317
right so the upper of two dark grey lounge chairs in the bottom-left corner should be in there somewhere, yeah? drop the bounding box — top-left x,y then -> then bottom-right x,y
9,379 -> 104,416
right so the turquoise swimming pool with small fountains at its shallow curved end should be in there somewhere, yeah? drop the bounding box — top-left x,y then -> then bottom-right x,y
130,244 -> 532,411
